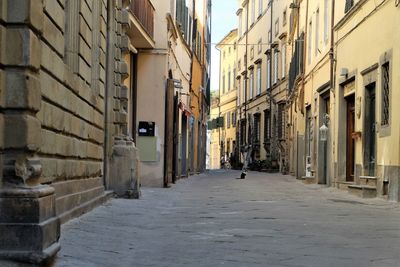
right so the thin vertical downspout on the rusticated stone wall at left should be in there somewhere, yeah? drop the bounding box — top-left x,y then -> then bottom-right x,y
103,0 -> 115,189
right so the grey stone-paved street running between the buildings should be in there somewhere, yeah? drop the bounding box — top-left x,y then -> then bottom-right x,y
55,171 -> 400,267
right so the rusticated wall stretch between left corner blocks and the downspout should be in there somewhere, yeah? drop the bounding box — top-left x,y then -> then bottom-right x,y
37,0 -> 107,222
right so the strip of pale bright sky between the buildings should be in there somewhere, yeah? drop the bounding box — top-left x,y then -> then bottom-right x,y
211,0 -> 238,91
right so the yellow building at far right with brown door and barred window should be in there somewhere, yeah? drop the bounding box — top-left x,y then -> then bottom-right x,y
334,0 -> 400,201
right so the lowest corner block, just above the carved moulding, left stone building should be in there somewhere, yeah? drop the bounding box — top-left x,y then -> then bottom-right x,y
4,114 -> 41,151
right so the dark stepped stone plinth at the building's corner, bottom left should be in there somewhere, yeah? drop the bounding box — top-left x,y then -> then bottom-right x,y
0,185 -> 60,263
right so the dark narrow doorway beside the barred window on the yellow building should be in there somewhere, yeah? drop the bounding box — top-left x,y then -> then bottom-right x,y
364,83 -> 376,176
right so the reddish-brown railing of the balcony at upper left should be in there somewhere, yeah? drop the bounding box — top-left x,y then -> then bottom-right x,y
130,0 -> 155,38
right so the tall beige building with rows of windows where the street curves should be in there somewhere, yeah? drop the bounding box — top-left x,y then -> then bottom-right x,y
236,0 -> 290,171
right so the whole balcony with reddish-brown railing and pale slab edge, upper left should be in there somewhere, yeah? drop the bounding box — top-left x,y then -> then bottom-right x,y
127,0 -> 155,48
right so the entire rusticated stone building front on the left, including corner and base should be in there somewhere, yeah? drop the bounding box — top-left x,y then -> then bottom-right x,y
0,0 -> 139,263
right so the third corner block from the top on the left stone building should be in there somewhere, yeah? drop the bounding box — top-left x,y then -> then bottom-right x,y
0,71 -> 42,111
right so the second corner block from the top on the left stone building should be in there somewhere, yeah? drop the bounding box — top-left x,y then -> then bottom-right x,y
0,28 -> 41,69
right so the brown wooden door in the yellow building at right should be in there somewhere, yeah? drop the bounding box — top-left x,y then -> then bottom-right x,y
346,94 -> 355,182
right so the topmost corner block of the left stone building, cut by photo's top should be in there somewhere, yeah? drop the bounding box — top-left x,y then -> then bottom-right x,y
3,0 -> 44,31
